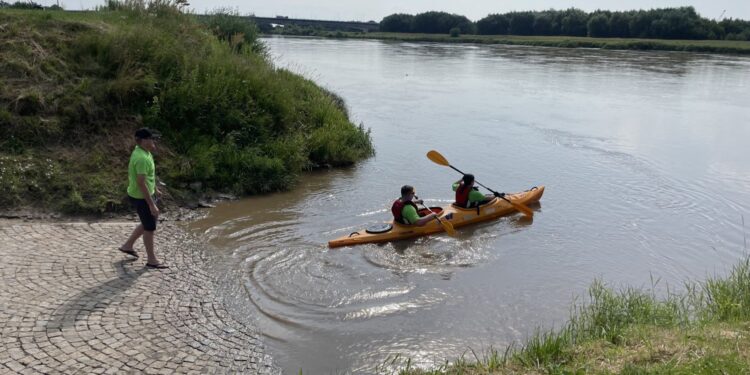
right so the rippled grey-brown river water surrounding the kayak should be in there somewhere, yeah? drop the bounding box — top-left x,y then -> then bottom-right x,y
192,38 -> 750,374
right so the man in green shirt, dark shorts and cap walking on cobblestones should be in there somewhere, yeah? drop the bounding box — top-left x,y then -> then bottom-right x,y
119,128 -> 169,269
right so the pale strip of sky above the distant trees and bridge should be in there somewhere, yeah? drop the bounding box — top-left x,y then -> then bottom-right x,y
42,0 -> 750,21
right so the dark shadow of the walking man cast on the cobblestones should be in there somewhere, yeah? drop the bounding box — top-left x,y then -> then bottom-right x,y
45,258 -> 146,332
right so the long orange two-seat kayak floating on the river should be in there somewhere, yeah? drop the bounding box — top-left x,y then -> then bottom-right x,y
328,186 -> 544,247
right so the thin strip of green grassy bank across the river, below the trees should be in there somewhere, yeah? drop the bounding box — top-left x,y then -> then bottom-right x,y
280,31 -> 750,55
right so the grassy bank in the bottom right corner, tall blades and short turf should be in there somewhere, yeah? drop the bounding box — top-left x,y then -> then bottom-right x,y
396,258 -> 750,375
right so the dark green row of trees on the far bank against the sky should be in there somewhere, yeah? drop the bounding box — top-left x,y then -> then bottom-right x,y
380,6 -> 750,40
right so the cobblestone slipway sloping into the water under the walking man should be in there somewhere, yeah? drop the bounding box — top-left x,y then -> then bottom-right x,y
0,220 -> 278,374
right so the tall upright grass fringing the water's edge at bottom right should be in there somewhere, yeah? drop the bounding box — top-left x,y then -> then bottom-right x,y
514,258 -> 750,368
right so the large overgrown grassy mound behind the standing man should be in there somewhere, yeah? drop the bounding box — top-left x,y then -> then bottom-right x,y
0,1 -> 373,213
